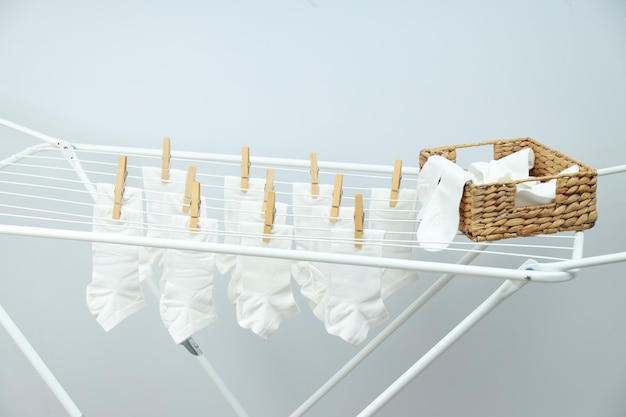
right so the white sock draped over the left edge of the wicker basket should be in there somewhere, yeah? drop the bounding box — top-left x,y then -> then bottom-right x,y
417,157 -> 472,251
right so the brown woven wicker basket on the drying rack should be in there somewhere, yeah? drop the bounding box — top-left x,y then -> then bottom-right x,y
420,138 -> 598,241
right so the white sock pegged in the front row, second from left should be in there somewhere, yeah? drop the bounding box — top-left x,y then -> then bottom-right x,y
160,216 -> 217,344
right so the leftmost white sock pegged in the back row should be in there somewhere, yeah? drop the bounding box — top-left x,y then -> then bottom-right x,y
140,166 -> 187,278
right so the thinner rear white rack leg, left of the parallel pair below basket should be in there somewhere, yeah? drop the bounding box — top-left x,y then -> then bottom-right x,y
290,244 -> 488,417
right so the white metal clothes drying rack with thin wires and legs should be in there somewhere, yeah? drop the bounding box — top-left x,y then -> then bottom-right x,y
0,119 -> 626,417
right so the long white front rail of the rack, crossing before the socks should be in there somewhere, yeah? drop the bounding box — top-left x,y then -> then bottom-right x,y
0,225 -> 574,282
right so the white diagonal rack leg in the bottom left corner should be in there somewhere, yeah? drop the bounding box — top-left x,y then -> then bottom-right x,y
0,305 -> 83,417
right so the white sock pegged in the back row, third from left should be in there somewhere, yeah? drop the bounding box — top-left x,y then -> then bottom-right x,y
291,182 -> 333,285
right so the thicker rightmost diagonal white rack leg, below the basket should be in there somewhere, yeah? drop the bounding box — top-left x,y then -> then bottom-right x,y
357,280 -> 526,417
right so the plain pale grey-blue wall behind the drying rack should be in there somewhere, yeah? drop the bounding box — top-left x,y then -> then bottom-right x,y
0,0 -> 626,417
